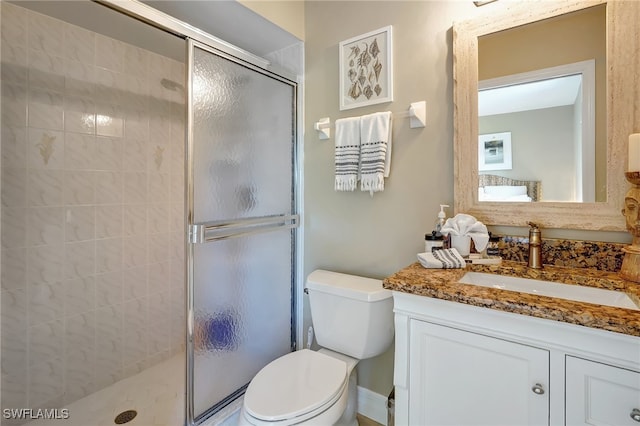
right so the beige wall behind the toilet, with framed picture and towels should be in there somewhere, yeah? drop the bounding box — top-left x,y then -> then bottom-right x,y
304,1 -> 628,395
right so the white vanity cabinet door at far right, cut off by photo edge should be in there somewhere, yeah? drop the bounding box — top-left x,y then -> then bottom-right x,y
565,356 -> 640,426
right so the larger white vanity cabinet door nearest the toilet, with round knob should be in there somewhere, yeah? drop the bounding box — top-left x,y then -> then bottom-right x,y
409,320 -> 549,426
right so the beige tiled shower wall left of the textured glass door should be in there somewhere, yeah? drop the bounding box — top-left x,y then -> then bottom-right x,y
0,2 -> 184,416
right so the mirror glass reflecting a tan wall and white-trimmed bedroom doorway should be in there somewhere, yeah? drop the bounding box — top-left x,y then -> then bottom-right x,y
478,5 -> 606,202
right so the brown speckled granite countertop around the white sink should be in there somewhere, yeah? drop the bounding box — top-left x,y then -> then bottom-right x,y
383,261 -> 640,336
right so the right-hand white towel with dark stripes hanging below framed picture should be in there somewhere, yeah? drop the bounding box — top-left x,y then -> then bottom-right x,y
360,111 -> 391,195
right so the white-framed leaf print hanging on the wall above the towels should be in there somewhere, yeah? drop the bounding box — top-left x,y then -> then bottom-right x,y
339,25 -> 393,111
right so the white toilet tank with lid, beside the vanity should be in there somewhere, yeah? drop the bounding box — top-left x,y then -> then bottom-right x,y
306,269 -> 394,359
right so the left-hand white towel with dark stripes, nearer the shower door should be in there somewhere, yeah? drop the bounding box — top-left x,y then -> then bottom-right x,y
335,117 -> 360,191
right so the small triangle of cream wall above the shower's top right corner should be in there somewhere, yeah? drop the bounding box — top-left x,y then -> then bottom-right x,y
238,0 -> 305,40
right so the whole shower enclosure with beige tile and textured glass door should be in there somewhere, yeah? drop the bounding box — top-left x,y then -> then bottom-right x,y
0,0 -> 297,425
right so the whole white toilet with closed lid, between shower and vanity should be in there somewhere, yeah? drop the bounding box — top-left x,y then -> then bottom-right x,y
239,270 -> 394,426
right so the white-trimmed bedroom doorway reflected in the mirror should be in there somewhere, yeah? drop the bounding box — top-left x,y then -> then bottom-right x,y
478,60 -> 596,202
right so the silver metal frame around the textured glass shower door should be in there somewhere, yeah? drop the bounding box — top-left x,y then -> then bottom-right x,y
90,0 -> 304,426
